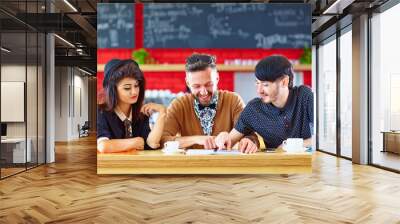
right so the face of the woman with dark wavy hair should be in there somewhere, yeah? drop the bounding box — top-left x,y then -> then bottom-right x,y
117,77 -> 140,104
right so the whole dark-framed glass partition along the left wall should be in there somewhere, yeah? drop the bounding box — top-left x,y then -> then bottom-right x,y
0,1 -> 46,178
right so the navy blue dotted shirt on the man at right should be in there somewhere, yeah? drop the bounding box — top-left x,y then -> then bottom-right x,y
235,86 -> 314,148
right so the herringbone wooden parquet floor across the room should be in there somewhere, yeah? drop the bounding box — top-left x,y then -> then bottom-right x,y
0,137 -> 400,224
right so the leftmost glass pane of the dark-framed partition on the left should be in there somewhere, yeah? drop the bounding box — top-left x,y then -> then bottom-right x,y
0,29 -> 27,178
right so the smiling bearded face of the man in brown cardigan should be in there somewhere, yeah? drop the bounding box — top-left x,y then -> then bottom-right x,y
186,67 -> 219,106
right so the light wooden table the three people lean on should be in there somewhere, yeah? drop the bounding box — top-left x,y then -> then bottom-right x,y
97,150 -> 312,174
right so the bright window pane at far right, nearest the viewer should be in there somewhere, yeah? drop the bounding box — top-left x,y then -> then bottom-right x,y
371,4 -> 400,170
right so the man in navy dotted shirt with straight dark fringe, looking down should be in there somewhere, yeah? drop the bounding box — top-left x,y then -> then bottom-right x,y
215,55 -> 314,153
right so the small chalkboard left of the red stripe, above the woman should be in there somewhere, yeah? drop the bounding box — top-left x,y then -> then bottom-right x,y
97,3 -> 135,48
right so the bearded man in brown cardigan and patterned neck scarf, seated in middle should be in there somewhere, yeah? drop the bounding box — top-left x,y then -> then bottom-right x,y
161,53 -> 259,153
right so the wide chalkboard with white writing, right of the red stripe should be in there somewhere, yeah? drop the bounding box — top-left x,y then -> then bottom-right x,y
143,3 -> 312,49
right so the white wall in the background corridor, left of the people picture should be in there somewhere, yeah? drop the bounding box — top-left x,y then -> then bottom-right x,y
55,67 -> 88,141
